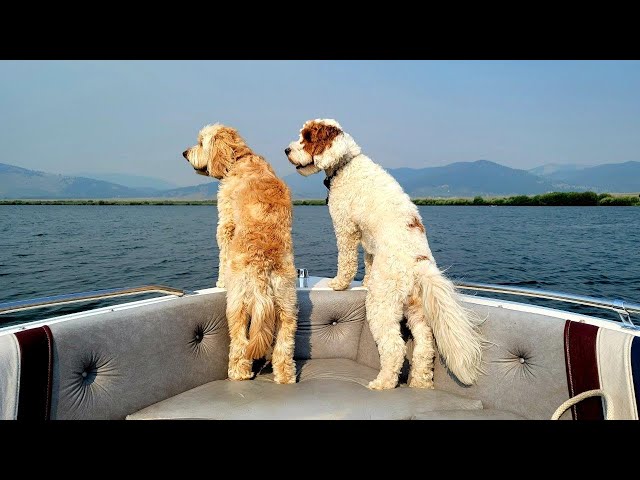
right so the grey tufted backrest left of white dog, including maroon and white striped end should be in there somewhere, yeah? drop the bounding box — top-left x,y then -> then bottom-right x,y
0,290 -> 365,419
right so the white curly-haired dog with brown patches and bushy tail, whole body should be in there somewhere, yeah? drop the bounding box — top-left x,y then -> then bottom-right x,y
285,119 -> 482,389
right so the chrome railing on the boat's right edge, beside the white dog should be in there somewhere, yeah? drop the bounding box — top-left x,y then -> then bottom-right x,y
455,282 -> 640,330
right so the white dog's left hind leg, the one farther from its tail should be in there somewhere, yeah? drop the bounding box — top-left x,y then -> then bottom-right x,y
365,271 -> 408,390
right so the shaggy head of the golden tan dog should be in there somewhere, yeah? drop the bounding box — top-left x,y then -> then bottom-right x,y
182,123 -> 249,180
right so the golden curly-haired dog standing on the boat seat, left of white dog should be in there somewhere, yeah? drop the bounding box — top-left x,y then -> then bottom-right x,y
183,123 -> 298,383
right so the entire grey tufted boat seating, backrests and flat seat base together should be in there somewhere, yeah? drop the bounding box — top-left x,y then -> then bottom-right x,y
8,289 -> 637,420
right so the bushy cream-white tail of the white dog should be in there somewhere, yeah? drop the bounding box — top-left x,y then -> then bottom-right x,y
418,261 -> 482,385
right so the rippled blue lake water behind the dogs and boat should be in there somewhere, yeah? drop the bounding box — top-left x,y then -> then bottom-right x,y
0,205 -> 640,326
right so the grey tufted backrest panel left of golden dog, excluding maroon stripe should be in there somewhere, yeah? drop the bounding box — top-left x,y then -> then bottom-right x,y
51,293 -> 229,419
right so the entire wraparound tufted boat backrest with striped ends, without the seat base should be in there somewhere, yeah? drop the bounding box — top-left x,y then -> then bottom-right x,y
0,290 -> 640,419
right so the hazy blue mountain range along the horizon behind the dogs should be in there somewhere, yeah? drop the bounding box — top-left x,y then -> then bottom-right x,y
0,160 -> 640,200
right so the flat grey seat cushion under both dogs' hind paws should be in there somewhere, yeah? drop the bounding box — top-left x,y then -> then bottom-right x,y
127,359 -> 482,420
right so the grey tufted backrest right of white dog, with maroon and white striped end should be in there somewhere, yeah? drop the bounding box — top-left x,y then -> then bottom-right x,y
358,302 -> 640,420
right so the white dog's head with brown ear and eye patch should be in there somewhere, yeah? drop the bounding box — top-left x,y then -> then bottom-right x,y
284,119 -> 360,177
